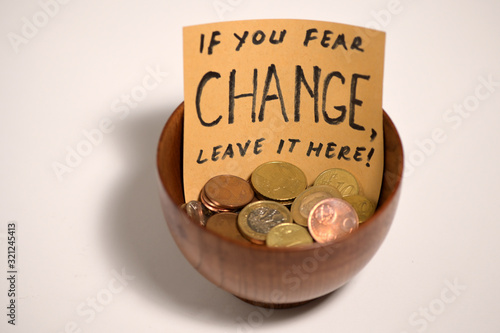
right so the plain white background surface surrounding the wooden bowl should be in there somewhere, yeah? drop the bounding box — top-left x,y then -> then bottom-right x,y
0,0 -> 500,333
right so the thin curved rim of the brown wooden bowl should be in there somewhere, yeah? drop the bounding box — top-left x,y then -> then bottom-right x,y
156,101 -> 404,253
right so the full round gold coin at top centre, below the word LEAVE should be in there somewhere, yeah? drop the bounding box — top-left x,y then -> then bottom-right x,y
251,161 -> 307,202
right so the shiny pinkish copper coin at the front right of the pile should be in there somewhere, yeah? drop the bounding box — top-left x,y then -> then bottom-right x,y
308,198 -> 359,243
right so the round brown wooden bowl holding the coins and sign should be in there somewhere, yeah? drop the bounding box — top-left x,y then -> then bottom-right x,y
157,104 -> 403,308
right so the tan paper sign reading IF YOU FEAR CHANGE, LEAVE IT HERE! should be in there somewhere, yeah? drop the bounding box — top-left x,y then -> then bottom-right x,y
183,20 -> 385,202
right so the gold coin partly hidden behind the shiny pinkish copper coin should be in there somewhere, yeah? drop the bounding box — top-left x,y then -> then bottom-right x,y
290,185 -> 342,227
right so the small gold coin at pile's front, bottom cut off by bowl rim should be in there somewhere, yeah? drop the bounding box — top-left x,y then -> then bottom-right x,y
266,223 -> 313,247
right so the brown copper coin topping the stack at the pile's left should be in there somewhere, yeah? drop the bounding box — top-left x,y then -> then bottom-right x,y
203,175 -> 254,210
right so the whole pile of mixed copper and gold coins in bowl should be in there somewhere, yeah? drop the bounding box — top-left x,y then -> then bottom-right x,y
182,161 -> 376,247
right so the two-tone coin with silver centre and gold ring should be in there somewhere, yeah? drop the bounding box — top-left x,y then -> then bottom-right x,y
238,200 -> 292,244
